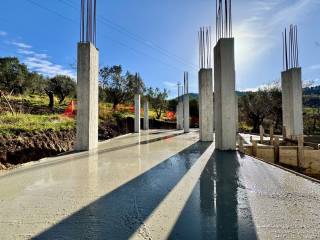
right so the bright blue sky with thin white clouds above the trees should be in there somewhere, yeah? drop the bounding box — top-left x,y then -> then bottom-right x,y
0,0 -> 320,96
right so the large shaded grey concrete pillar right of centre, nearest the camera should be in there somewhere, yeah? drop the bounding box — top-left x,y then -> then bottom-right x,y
214,38 -> 237,150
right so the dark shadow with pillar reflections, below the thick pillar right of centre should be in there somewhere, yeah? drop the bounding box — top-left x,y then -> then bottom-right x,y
169,151 -> 258,240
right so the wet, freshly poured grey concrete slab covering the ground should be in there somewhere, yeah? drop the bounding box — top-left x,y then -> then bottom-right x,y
0,130 -> 320,239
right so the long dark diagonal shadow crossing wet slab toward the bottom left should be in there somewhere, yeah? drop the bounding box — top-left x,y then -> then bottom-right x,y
34,140 -> 211,239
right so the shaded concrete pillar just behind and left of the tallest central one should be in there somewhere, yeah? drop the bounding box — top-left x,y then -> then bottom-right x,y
199,69 -> 214,142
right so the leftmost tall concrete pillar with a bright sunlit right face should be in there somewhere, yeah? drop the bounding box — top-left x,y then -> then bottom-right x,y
75,43 -> 99,151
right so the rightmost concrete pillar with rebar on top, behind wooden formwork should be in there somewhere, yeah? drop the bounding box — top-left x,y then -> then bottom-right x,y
281,68 -> 303,138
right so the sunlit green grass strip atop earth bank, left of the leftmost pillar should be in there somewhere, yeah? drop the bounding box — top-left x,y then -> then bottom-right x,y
0,113 -> 75,135
